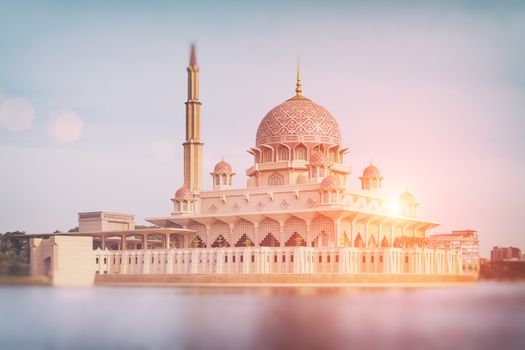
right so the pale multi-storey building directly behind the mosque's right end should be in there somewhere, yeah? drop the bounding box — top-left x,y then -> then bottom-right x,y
428,230 -> 480,273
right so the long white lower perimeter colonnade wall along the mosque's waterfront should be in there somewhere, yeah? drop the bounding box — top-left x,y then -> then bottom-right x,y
93,247 -> 463,274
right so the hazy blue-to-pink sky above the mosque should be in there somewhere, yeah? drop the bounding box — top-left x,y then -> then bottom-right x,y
0,0 -> 525,256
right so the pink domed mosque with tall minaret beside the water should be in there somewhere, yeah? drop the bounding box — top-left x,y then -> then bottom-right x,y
31,46 -> 463,288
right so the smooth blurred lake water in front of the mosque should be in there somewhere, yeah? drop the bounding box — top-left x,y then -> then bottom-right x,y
0,283 -> 525,350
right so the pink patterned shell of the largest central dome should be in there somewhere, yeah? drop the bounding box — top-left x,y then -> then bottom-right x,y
256,97 -> 341,146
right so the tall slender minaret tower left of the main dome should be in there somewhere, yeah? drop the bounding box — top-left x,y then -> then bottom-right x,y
183,44 -> 204,194
